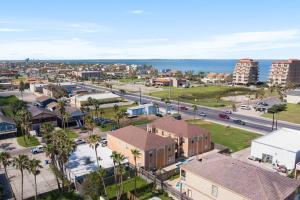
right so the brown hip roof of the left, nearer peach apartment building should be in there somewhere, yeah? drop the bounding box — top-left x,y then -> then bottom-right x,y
108,126 -> 175,151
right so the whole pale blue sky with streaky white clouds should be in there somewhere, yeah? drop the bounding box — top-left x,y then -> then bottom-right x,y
0,0 -> 300,60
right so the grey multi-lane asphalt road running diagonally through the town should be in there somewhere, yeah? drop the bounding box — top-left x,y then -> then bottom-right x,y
81,84 -> 300,133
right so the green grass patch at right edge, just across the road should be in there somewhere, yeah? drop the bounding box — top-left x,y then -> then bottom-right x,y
262,103 -> 300,124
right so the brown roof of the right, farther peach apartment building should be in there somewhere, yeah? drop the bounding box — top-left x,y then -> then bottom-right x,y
148,117 -> 210,138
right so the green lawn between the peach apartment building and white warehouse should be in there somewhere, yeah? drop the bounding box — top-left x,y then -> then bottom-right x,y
188,120 -> 260,152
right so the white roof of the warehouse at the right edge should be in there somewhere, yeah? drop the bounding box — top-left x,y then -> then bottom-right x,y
253,128 -> 300,152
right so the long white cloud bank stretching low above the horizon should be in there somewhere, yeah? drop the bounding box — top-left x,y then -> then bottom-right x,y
0,30 -> 300,59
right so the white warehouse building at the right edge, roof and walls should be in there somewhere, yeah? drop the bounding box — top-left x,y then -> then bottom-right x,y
251,128 -> 300,169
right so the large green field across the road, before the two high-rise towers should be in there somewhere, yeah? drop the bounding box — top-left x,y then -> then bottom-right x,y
150,86 -> 253,107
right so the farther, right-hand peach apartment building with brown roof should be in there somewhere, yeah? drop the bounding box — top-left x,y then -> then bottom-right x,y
147,117 -> 211,158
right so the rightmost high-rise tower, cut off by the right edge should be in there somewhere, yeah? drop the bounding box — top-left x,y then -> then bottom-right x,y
269,59 -> 300,86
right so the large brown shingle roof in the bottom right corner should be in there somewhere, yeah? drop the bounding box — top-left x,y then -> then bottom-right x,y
182,154 -> 300,200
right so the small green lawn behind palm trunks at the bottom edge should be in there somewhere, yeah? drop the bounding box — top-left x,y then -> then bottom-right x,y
106,177 -> 148,199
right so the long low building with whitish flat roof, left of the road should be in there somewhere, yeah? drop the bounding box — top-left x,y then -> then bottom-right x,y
71,92 -> 121,108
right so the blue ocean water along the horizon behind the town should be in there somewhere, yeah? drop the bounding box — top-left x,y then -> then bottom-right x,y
50,59 -> 272,81
